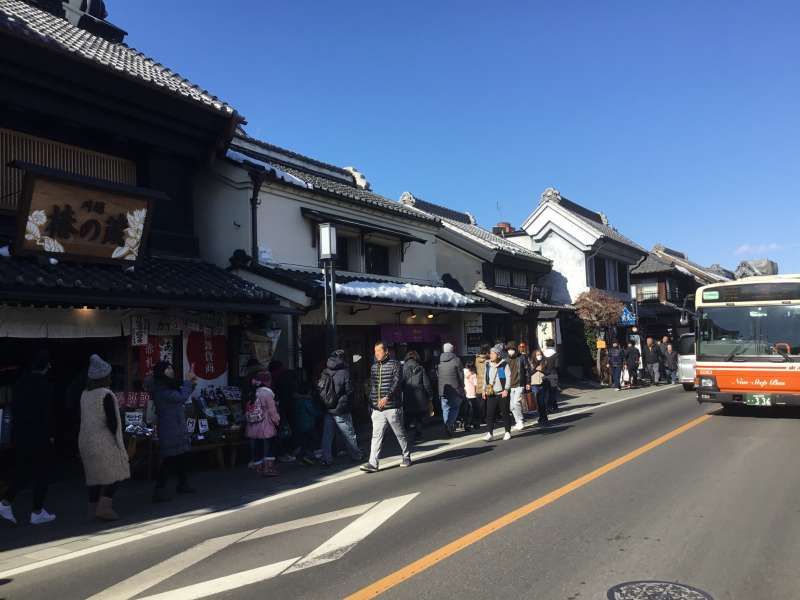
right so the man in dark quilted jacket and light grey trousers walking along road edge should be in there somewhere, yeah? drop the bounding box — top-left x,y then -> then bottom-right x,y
361,342 -> 411,473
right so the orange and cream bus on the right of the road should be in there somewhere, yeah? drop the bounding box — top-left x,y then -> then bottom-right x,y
695,275 -> 800,408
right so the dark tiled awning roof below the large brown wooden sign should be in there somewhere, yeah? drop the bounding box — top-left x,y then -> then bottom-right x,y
0,256 -> 296,314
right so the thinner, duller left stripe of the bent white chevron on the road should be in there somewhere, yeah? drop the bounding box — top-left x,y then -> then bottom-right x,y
89,502 -> 377,600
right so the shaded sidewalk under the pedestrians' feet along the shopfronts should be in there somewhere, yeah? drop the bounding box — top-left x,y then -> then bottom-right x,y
0,384 -> 664,572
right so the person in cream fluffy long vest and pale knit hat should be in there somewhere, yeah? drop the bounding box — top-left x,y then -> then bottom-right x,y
78,354 -> 131,521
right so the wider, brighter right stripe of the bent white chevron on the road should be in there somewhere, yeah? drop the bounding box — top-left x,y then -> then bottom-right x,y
133,492 -> 419,600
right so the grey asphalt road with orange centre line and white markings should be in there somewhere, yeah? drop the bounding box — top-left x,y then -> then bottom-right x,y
0,387 -> 800,600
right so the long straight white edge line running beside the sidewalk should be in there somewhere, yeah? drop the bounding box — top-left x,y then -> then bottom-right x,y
0,386 -> 680,579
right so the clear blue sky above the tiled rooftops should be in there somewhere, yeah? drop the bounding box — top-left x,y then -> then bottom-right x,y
112,0 -> 800,273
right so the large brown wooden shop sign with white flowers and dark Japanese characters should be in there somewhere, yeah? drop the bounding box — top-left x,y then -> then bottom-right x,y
14,172 -> 151,263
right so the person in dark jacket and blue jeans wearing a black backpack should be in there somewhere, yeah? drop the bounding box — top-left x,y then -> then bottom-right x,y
317,350 -> 363,467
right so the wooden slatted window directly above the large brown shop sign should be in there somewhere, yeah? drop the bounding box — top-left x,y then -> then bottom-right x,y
0,128 -> 136,211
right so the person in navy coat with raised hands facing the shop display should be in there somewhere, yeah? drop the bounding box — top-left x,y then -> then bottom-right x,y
152,361 -> 197,502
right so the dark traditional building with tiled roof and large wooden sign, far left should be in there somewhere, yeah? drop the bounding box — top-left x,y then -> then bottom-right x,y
0,0 -> 287,460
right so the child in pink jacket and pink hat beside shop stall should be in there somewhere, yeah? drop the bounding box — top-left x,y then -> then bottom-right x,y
245,372 -> 281,477
